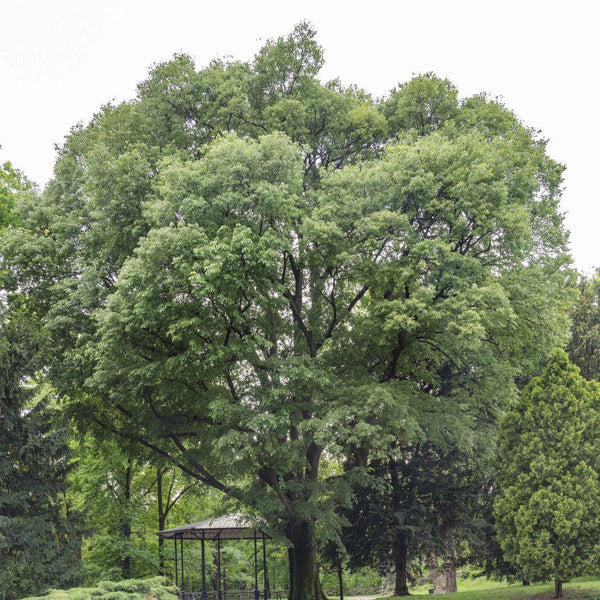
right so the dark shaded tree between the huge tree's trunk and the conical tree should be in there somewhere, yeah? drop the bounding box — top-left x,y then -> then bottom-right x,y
343,439 -> 495,596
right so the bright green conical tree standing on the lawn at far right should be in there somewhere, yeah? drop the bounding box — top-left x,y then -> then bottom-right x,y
495,350 -> 600,597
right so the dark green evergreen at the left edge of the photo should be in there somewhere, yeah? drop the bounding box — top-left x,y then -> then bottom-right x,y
0,314 -> 81,599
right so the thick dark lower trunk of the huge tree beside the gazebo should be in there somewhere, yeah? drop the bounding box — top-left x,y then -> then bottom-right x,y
287,520 -> 325,600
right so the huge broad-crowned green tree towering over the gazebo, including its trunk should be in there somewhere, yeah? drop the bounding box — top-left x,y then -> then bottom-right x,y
3,24 -> 567,600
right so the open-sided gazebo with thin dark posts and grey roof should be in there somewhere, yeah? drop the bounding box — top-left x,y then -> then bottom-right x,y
156,513 -> 271,600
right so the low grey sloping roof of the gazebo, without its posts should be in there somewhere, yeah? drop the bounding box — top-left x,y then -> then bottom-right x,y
156,513 -> 270,540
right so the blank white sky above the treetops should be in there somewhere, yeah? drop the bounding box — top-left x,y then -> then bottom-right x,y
0,0 -> 600,273
